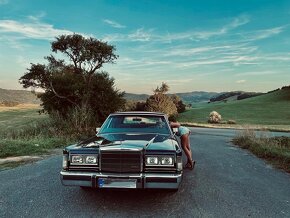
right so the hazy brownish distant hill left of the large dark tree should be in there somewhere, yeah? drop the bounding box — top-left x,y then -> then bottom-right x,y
0,88 -> 40,104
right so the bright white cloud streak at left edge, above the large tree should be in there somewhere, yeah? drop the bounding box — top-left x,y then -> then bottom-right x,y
0,17 -> 72,40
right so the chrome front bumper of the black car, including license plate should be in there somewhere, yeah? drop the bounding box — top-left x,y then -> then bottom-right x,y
60,170 -> 182,189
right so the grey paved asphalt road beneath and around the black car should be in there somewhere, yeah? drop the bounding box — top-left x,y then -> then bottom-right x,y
0,128 -> 290,217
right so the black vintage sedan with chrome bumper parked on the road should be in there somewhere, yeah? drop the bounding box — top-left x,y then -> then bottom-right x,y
60,112 -> 182,190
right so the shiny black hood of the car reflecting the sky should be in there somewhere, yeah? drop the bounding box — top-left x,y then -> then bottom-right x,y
80,133 -> 176,151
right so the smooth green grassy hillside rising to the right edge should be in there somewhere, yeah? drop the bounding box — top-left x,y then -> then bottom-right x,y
178,89 -> 290,125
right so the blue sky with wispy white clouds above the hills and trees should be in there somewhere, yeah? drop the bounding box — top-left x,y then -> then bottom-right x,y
0,0 -> 290,94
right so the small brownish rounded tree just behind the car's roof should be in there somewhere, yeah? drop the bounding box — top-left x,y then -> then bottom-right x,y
145,83 -> 177,116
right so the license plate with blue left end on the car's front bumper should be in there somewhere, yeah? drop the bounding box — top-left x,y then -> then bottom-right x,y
98,178 -> 137,188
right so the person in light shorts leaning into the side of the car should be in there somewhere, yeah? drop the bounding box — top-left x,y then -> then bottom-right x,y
170,121 -> 195,170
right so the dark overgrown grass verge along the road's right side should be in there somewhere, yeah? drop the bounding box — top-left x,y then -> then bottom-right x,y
233,130 -> 290,173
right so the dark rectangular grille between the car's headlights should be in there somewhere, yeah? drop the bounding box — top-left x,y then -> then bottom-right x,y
100,150 -> 142,173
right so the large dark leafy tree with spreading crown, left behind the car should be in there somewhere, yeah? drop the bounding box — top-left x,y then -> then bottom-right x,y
19,34 -> 125,126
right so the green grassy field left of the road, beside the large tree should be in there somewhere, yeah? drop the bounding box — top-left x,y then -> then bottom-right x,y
0,109 -> 76,158
